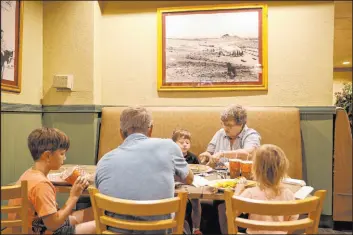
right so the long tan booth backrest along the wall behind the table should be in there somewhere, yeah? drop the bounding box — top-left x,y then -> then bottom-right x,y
98,107 -> 302,179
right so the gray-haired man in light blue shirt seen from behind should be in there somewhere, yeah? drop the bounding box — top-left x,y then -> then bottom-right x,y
95,107 -> 194,234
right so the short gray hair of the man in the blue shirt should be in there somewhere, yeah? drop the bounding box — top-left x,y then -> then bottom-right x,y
120,106 -> 152,137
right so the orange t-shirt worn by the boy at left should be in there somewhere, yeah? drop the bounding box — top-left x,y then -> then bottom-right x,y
9,168 -> 58,234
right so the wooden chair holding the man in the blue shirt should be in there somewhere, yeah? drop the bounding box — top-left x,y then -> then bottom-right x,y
88,186 -> 187,234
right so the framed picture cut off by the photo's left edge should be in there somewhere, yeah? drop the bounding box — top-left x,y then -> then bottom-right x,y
1,1 -> 24,93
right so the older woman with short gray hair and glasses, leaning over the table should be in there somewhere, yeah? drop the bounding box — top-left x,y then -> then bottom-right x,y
199,105 -> 261,165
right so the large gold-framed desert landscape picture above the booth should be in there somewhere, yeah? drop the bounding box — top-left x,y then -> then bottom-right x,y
157,5 -> 267,91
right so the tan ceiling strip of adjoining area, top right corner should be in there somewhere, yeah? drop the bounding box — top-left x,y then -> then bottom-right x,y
333,1 -> 352,69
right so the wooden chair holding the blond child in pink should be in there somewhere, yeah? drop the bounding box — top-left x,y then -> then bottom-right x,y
224,190 -> 326,234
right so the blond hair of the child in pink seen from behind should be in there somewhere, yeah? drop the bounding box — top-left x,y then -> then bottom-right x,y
252,144 -> 289,195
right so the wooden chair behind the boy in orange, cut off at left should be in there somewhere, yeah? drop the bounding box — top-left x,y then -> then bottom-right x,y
1,181 -> 29,234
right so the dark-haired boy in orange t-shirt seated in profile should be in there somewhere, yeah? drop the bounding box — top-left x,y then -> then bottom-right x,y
9,127 -> 96,235
